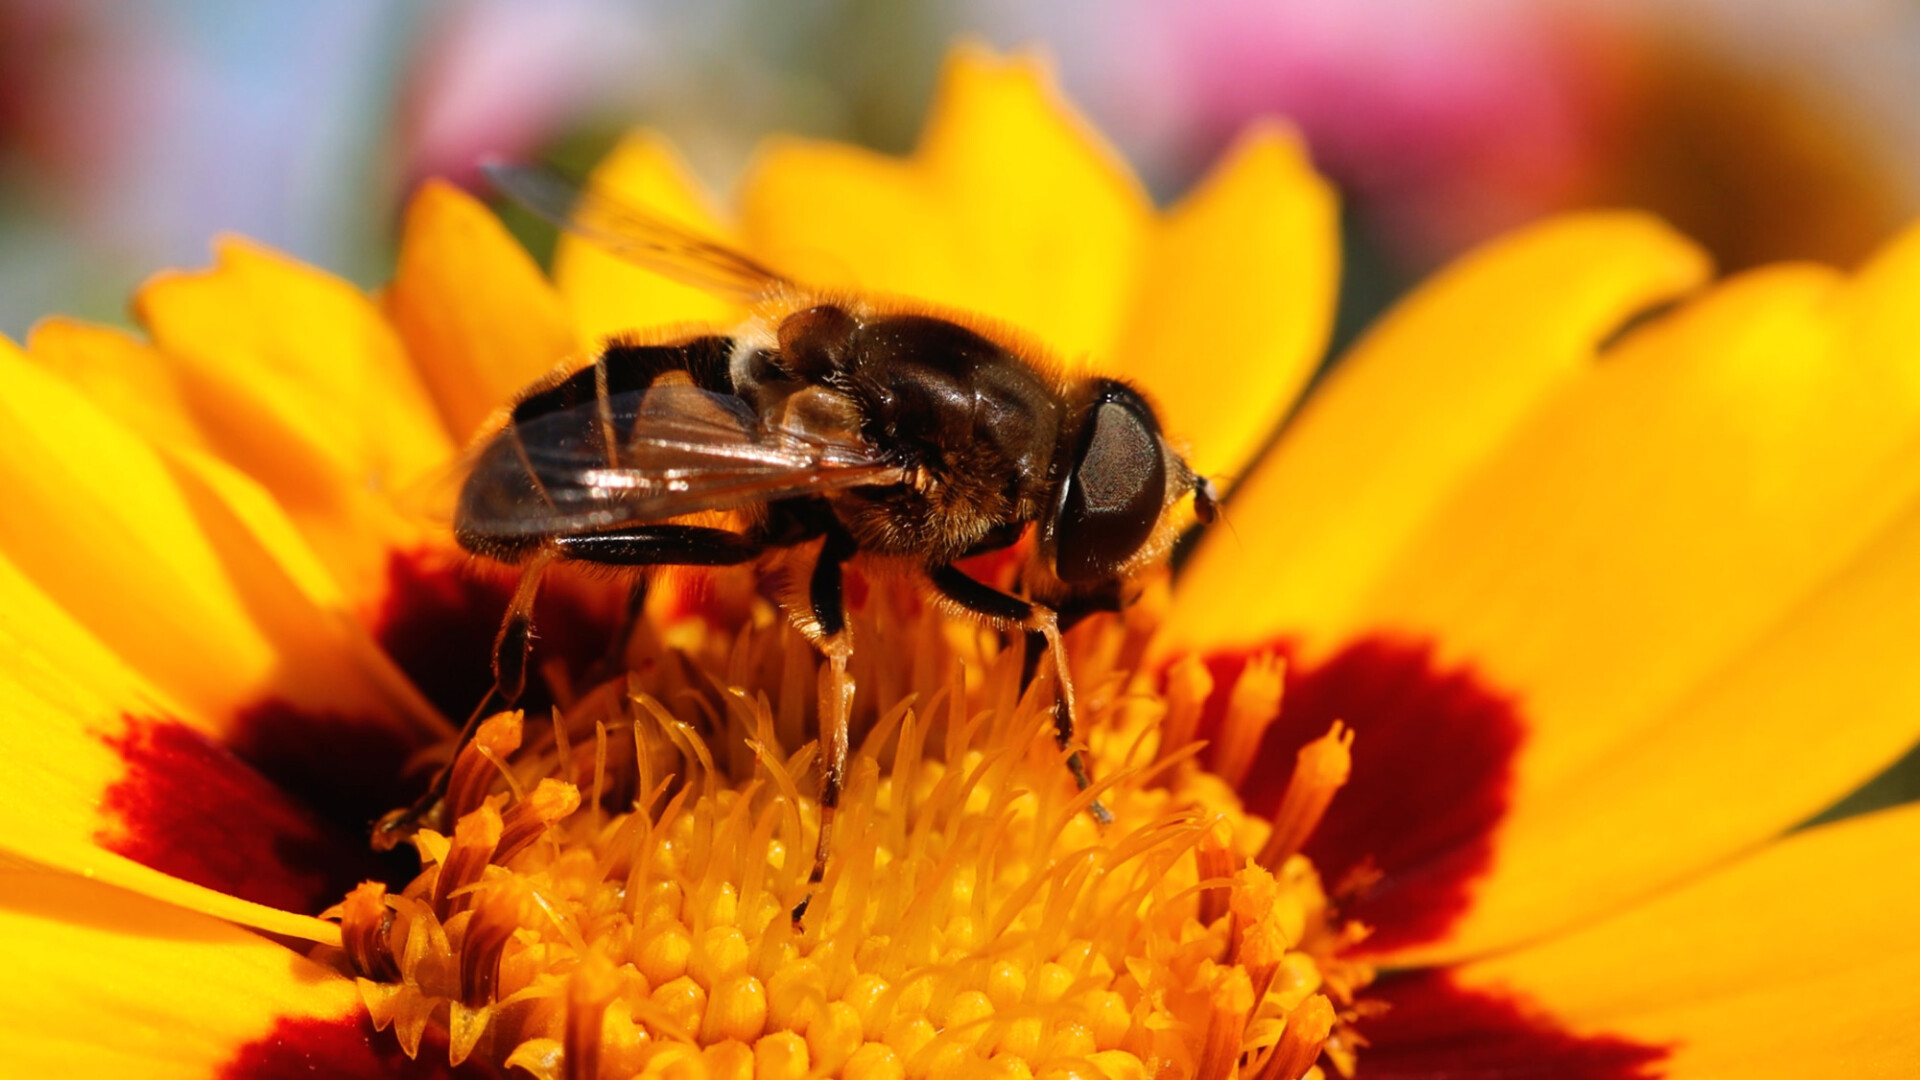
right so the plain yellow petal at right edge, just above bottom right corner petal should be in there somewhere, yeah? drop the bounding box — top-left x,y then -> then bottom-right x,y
1450,453 -> 1920,951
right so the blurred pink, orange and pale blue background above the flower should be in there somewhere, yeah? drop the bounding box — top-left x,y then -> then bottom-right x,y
0,0 -> 1920,805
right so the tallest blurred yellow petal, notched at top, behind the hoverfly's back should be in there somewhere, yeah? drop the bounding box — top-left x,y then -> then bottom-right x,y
741,48 -> 1152,363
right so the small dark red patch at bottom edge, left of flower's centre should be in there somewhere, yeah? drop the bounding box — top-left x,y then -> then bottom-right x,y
215,1013 -> 505,1080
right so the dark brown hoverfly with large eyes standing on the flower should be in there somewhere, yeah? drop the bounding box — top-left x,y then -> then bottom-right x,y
397,163 -> 1217,919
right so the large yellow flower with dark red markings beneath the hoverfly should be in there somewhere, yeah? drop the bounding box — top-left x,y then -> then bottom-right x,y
0,44 -> 1920,1080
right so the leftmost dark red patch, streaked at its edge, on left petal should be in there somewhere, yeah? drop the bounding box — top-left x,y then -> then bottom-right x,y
96,717 -> 397,915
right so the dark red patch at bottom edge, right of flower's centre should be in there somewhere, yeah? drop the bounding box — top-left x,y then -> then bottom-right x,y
1357,970 -> 1670,1080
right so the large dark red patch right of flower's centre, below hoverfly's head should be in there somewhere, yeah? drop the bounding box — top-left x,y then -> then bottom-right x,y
1200,638 -> 1526,951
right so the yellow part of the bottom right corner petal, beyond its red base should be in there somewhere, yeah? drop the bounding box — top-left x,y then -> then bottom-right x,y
1455,807 -> 1920,1080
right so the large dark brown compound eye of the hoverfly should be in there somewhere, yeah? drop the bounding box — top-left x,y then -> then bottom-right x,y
1054,388 -> 1167,582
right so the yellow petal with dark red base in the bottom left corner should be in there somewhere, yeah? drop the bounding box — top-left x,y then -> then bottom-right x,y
0,871 -> 362,1080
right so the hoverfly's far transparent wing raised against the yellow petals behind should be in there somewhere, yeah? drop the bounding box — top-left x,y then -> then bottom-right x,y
480,161 -> 793,302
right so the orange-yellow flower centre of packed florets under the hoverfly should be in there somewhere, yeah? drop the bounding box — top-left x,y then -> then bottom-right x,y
332,590 -> 1373,1080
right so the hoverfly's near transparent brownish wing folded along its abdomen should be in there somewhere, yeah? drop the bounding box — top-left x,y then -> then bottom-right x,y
459,386 -> 902,536
